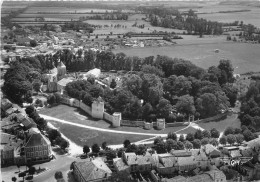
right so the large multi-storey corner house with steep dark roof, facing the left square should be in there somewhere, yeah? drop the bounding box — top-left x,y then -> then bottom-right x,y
22,132 -> 52,163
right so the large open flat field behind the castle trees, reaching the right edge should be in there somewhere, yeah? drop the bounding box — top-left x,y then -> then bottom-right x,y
113,40 -> 260,74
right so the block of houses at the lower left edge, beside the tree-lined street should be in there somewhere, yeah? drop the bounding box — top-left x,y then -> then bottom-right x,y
0,99 -> 52,167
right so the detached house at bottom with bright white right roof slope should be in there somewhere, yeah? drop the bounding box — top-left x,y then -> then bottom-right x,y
73,158 -> 112,182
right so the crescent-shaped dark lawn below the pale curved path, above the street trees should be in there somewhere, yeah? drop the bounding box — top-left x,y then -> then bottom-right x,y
49,121 -> 152,146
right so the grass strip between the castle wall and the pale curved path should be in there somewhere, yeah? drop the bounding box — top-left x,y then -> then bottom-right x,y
39,105 -> 185,134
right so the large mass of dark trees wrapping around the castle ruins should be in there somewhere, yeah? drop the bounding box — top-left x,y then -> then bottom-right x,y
3,49 -> 237,122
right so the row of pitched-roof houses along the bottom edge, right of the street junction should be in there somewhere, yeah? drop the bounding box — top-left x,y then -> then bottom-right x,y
70,138 -> 260,182
